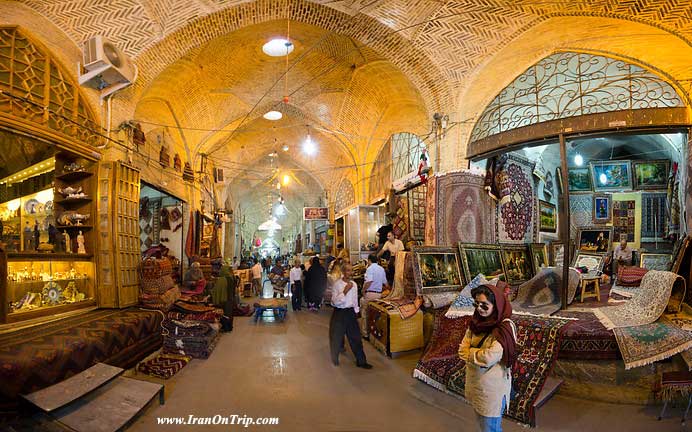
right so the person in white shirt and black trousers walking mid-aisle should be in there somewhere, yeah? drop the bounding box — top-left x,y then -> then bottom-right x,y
329,262 -> 372,369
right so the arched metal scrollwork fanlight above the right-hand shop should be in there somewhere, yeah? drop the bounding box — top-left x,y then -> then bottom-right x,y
471,52 -> 685,142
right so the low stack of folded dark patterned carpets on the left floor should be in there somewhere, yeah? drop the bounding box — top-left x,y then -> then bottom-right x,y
161,300 -> 223,359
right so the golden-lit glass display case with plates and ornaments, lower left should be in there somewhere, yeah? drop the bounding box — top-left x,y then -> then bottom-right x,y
2,253 -> 95,322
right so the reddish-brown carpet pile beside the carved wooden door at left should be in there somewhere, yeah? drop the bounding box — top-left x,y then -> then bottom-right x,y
139,257 -> 180,311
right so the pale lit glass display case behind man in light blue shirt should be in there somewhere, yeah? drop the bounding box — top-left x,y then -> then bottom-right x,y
344,205 -> 384,263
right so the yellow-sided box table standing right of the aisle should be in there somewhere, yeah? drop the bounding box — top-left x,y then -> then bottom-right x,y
367,301 -> 424,357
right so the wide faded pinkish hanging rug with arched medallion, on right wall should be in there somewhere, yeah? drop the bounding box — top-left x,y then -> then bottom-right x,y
428,170 -> 496,245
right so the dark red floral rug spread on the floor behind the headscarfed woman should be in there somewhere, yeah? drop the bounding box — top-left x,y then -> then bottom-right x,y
413,310 -> 569,424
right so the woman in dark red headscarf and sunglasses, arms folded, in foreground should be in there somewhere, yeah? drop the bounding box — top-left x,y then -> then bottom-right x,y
459,285 -> 517,432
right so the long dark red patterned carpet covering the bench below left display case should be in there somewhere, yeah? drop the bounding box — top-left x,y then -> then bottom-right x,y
0,308 -> 163,415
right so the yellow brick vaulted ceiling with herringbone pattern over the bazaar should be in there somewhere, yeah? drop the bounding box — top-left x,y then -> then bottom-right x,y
12,0 -> 692,216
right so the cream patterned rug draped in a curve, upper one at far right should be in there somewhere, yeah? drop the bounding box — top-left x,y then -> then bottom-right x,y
594,270 -> 685,329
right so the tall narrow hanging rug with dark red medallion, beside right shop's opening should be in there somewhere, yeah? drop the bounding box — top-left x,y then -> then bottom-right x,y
494,154 -> 536,244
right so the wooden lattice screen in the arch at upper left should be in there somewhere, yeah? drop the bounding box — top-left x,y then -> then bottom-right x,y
0,26 -> 105,146
